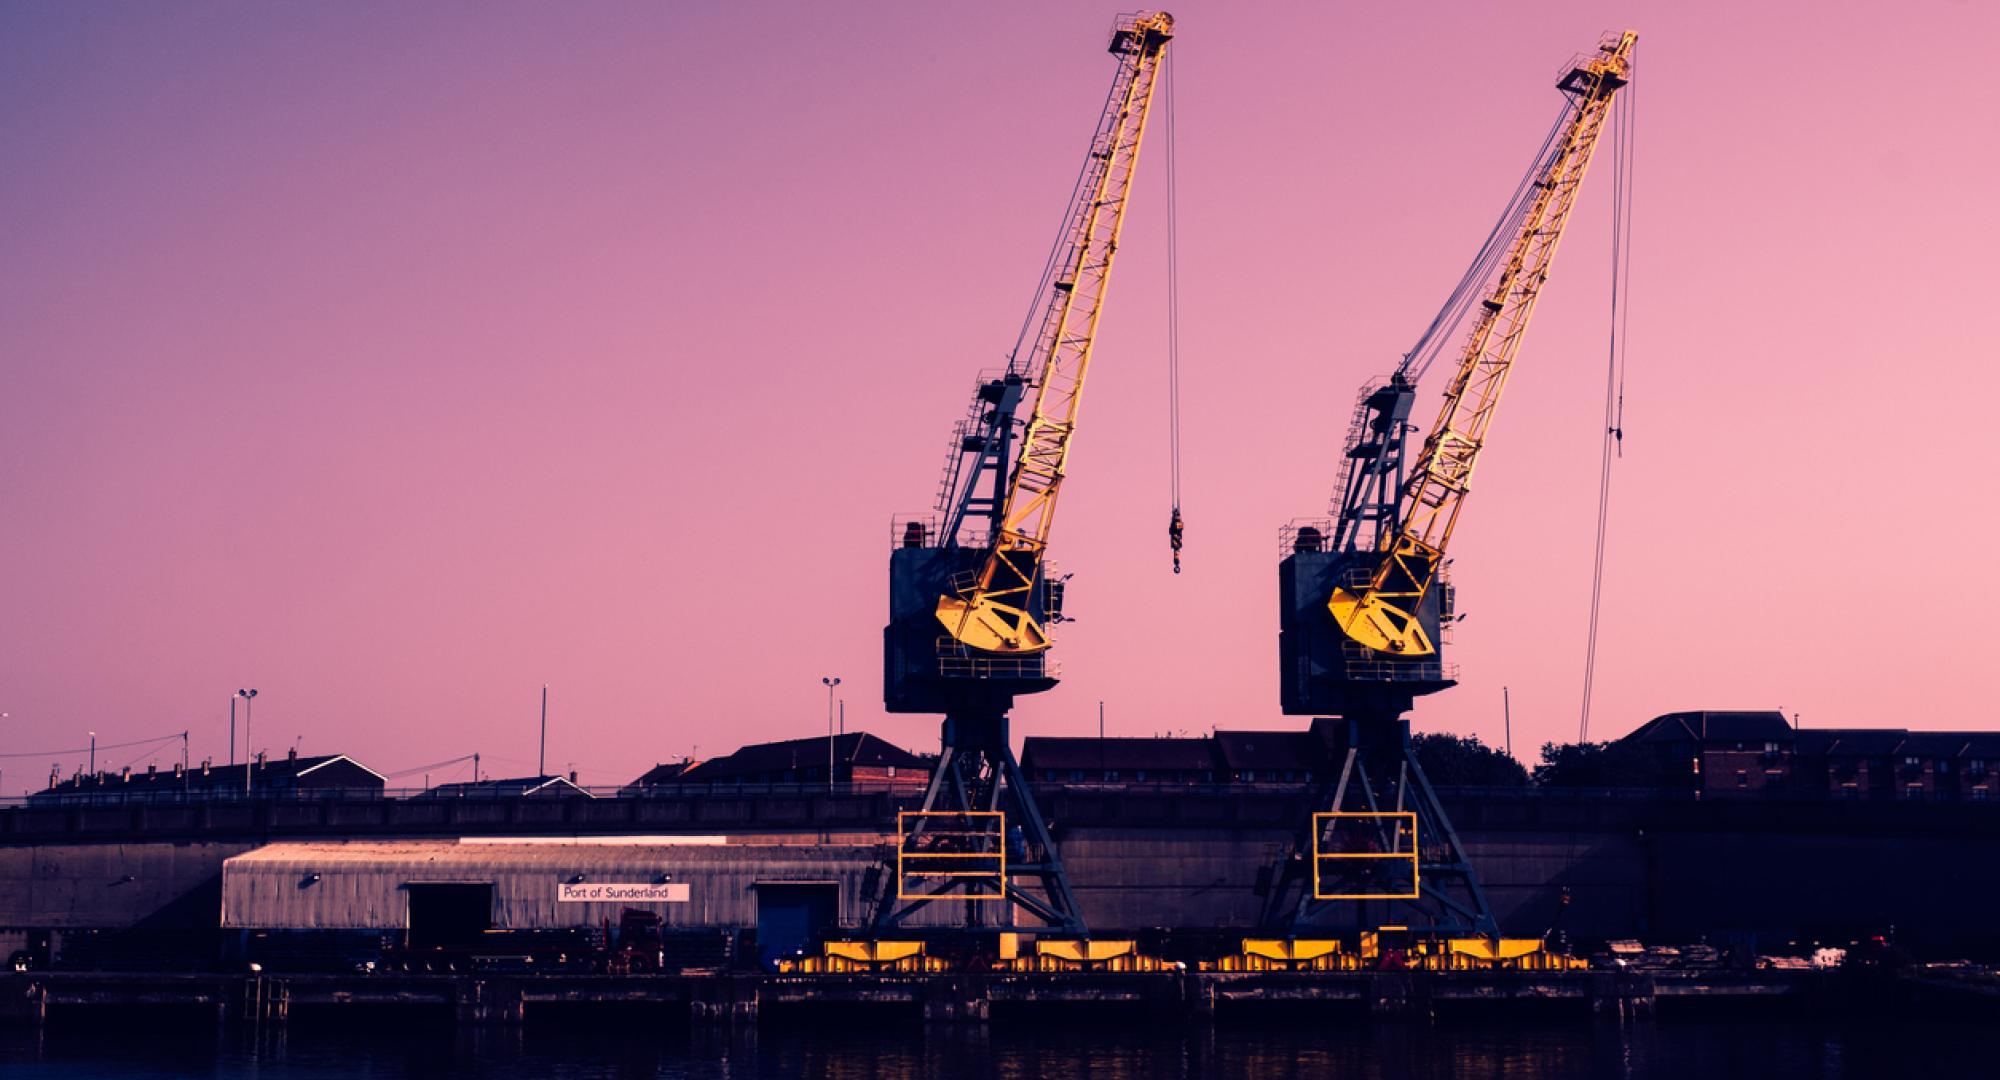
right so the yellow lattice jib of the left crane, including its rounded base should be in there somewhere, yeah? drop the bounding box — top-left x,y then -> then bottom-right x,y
938,12 -> 1174,654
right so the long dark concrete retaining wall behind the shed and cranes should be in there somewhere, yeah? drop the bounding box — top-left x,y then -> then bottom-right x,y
0,788 -> 2000,948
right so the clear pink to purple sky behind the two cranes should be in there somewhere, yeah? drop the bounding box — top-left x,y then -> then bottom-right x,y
0,0 -> 2000,794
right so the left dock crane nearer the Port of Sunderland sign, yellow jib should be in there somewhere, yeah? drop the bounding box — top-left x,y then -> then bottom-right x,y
874,12 -> 1174,936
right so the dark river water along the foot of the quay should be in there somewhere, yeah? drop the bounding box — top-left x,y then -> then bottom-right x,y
0,1014 -> 1976,1080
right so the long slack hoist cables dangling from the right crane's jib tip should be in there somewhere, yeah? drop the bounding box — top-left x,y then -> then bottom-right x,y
1576,58 -> 1638,742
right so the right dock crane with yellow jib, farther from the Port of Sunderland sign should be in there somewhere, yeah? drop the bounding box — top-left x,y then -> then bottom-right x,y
1264,32 -> 1638,936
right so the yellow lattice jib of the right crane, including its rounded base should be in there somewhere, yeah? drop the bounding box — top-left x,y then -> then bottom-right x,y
1328,32 -> 1638,656
